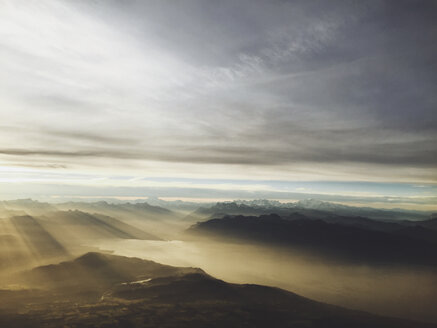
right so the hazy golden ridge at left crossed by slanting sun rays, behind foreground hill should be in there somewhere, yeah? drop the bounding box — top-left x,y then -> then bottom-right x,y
0,211 -> 159,274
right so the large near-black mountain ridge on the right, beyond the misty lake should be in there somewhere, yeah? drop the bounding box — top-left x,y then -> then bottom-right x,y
187,214 -> 437,265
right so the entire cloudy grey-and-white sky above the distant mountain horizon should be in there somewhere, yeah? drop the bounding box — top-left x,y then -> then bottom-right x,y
0,0 -> 437,208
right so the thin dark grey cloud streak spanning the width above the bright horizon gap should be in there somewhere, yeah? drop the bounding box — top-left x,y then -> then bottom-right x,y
0,136 -> 437,168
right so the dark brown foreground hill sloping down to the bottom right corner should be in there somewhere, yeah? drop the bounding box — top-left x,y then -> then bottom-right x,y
0,253 -> 437,328
